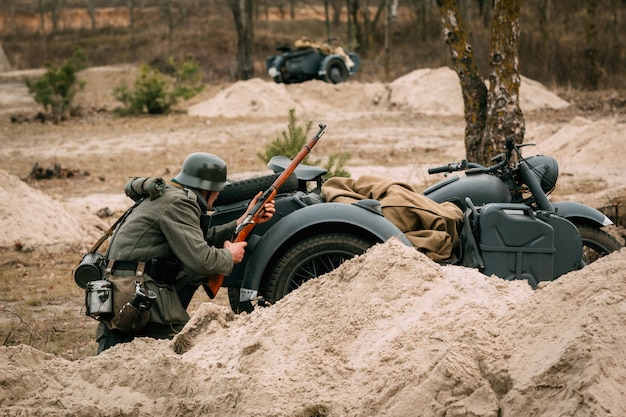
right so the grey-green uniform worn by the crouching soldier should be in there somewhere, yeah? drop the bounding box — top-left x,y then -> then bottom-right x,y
96,179 -> 236,353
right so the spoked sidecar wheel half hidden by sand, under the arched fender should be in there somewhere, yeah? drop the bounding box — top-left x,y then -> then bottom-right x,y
266,233 -> 373,304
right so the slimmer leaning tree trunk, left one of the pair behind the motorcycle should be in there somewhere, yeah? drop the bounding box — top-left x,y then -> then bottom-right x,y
437,0 -> 487,163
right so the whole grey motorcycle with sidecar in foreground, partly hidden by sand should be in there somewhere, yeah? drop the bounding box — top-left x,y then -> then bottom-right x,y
208,140 -> 621,313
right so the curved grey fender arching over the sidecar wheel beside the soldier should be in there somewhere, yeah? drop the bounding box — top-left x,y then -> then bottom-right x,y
239,203 -> 412,302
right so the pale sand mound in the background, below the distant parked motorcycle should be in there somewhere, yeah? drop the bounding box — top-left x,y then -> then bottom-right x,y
189,67 -> 568,118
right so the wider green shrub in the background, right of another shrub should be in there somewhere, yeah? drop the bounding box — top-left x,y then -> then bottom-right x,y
113,56 -> 204,116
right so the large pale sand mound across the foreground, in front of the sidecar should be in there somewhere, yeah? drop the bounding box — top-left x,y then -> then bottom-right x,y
0,241 -> 626,417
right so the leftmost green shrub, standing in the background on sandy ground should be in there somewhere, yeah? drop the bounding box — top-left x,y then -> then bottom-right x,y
25,48 -> 87,123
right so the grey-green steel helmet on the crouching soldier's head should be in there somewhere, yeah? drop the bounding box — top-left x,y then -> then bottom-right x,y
174,152 -> 226,191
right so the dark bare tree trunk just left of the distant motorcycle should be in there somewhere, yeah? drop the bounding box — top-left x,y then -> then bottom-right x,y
228,0 -> 254,80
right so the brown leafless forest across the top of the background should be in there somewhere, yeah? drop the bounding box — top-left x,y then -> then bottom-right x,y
0,0 -> 626,91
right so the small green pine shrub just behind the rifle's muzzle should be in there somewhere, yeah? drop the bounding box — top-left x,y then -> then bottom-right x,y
257,109 -> 350,178
